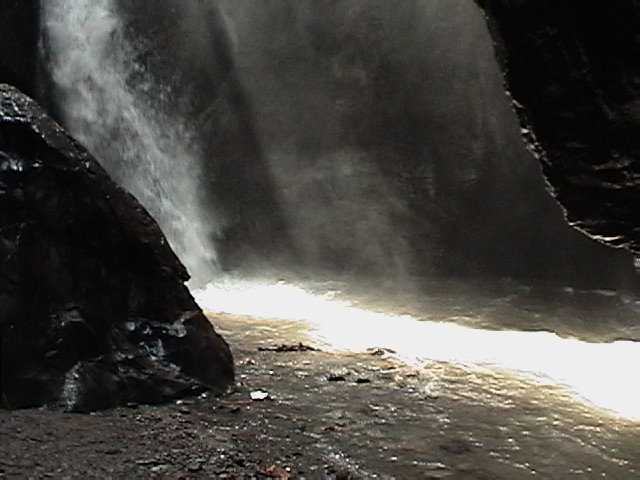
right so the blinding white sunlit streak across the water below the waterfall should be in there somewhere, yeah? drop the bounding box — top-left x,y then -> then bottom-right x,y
195,282 -> 640,420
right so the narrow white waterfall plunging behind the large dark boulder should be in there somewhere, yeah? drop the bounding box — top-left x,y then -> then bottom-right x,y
42,0 -> 217,283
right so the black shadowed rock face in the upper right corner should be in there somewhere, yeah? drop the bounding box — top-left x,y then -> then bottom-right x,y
478,0 -> 640,257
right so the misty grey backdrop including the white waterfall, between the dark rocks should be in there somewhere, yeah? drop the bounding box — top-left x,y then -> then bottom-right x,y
44,0 -> 637,289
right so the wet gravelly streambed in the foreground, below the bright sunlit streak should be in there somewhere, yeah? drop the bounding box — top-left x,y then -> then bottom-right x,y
0,315 -> 640,479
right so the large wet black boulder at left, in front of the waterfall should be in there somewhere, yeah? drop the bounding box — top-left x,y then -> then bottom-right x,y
0,85 -> 234,411
